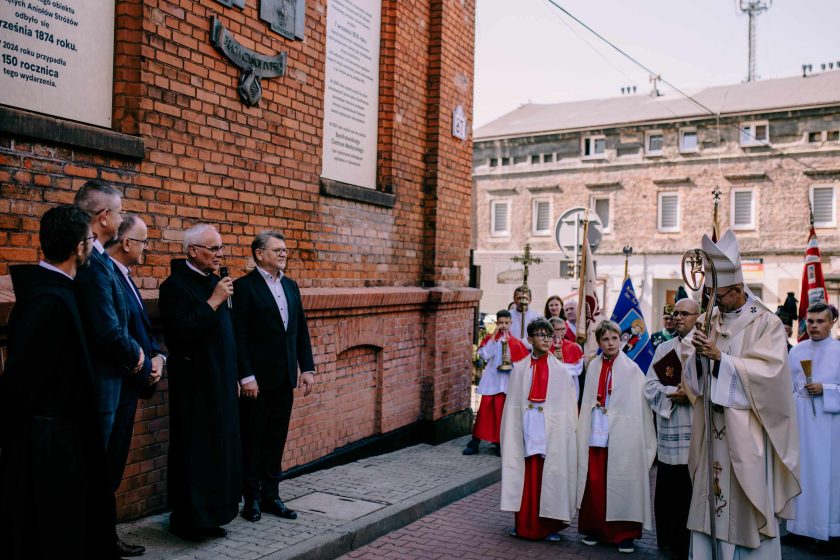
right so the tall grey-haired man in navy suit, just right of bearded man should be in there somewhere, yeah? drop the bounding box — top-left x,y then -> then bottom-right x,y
74,180 -> 149,558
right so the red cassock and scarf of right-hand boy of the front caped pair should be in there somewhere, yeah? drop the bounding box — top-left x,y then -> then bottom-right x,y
578,354 -> 642,544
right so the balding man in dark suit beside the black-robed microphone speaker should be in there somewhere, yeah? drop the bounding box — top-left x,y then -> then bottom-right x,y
105,214 -> 166,546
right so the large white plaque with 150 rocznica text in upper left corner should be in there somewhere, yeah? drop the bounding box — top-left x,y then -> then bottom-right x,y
0,0 -> 114,127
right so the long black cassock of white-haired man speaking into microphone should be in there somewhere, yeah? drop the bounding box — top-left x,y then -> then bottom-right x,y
159,259 -> 242,528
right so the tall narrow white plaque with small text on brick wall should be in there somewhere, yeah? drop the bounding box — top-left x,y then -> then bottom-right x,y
320,0 -> 382,189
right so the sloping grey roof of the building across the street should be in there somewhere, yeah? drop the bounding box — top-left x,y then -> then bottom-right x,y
475,70 -> 840,140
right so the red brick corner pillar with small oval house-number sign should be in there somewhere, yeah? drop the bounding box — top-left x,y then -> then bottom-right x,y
421,0 -> 477,439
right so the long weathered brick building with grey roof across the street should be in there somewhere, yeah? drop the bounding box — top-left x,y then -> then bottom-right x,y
473,71 -> 840,329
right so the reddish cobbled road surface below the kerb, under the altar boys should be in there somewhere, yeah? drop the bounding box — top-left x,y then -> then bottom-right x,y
340,483 -> 815,560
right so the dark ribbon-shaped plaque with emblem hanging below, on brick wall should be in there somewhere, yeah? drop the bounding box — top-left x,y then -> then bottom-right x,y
210,16 -> 286,107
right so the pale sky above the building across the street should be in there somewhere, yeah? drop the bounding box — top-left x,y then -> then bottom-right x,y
473,0 -> 840,127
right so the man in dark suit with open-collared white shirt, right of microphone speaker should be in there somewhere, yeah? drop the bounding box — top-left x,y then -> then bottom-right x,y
233,232 -> 315,521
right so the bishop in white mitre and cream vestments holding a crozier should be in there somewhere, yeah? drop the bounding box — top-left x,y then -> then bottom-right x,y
685,231 -> 799,560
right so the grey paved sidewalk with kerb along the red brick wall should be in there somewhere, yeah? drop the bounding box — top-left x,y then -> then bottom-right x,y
119,437 -> 501,560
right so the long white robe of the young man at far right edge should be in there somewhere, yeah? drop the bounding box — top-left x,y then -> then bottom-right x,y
787,336 -> 840,541
